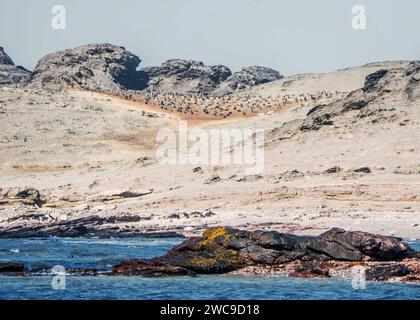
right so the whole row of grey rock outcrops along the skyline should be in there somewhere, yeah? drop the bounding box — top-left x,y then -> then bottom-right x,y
0,44 -> 281,96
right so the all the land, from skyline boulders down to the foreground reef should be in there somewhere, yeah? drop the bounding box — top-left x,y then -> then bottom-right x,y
0,44 -> 420,283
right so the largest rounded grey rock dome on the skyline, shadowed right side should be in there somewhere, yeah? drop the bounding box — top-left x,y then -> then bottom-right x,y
31,44 -> 144,93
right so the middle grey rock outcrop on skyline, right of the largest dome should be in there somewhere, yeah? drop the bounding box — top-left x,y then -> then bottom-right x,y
141,59 -> 232,94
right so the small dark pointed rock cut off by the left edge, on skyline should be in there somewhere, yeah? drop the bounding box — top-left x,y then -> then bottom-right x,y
0,47 -> 32,86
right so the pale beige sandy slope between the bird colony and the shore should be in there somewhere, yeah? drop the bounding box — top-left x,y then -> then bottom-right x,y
0,63 -> 420,239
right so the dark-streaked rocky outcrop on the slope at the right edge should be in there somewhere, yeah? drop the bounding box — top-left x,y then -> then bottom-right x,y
262,61 -> 420,140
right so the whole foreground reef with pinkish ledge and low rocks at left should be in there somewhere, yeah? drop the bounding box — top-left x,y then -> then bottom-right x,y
0,227 -> 420,284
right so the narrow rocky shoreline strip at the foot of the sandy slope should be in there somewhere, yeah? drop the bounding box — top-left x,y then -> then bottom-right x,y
0,211 -> 420,241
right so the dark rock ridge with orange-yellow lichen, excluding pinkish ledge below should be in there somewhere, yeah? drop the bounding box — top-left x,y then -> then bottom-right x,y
113,227 -> 420,276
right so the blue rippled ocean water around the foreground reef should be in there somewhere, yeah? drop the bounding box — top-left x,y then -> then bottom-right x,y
0,238 -> 420,300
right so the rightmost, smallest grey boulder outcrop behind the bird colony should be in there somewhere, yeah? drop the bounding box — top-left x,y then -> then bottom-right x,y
214,66 -> 283,96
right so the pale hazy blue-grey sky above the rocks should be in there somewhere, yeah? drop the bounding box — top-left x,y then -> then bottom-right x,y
0,0 -> 420,75
